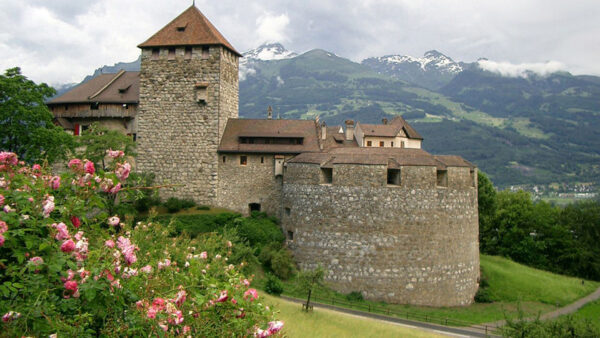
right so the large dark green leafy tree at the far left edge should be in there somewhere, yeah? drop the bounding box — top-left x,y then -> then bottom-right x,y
0,68 -> 75,163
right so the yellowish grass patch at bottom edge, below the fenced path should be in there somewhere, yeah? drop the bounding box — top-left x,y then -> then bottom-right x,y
261,293 -> 443,337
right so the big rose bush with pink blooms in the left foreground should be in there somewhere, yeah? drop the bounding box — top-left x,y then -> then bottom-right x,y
0,150 -> 283,337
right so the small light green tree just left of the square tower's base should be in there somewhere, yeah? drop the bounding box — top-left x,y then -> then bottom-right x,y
78,122 -> 135,169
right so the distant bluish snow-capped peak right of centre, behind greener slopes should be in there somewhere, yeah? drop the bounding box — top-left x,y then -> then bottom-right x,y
362,50 -> 463,89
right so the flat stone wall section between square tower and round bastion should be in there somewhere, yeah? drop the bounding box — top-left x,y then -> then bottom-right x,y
217,154 -> 282,217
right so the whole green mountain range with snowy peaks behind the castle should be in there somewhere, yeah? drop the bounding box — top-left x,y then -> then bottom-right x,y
51,43 -> 600,187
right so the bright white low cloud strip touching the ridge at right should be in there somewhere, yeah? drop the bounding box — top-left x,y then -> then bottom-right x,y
477,60 -> 566,78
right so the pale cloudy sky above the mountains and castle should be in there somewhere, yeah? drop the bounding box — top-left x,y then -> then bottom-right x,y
0,0 -> 600,85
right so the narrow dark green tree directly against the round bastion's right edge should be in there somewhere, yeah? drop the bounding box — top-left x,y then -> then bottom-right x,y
477,171 -> 497,253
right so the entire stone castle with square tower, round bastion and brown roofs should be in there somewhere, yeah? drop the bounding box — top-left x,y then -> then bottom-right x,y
48,6 -> 479,306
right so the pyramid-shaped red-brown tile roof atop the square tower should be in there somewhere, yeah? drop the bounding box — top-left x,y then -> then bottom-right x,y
138,5 -> 242,56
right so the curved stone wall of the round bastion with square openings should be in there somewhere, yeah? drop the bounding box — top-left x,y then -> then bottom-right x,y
282,163 -> 479,306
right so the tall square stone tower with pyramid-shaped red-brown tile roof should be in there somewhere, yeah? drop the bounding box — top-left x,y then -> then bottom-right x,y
136,6 -> 241,204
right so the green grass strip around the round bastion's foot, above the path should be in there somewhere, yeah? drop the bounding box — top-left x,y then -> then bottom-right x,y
257,255 -> 600,326
